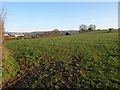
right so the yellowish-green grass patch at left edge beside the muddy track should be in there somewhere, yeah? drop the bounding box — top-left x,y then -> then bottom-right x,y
2,49 -> 20,83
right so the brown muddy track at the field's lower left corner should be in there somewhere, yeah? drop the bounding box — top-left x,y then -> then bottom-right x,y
2,64 -> 45,90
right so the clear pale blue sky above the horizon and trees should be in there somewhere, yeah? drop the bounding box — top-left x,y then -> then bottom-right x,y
2,2 -> 118,32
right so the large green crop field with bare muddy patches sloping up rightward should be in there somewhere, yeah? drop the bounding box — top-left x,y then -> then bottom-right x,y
3,31 -> 120,88
